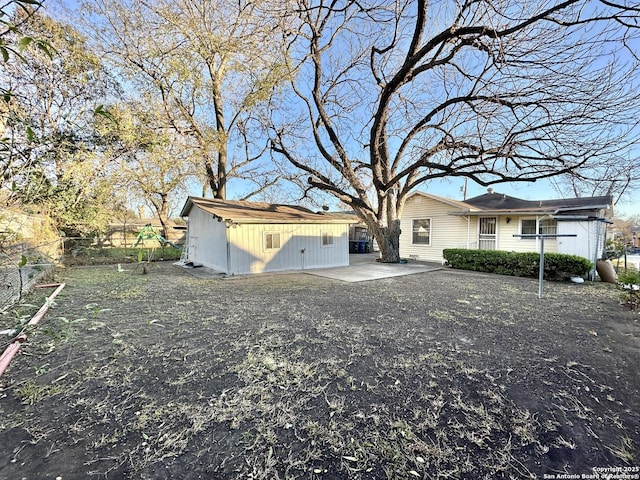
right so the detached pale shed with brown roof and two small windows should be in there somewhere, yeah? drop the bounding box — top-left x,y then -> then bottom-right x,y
180,197 -> 357,275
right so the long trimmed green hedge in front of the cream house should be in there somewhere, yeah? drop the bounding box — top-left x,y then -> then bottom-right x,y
442,248 -> 593,280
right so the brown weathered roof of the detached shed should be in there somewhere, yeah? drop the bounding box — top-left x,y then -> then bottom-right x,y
180,197 -> 358,224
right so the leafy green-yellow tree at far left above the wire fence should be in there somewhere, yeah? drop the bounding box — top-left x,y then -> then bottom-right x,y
1,10 -> 117,235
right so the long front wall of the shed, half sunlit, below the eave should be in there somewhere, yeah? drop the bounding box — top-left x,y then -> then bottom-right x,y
227,224 -> 349,275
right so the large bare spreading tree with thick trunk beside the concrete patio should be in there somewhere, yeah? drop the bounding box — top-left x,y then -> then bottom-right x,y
272,0 -> 640,262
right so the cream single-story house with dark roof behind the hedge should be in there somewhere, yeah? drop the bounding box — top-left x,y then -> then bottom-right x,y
400,189 -> 613,263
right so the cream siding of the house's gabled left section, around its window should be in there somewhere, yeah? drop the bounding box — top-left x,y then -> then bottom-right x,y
400,195 -> 478,262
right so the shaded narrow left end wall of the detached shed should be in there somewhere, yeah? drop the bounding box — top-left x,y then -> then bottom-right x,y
187,208 -> 227,272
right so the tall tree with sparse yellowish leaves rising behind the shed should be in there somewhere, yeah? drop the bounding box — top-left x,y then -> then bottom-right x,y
82,0 -> 283,198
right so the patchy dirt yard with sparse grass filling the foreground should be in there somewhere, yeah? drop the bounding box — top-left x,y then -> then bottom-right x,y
0,263 -> 640,480
